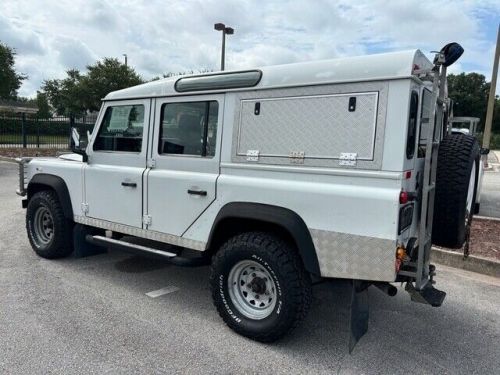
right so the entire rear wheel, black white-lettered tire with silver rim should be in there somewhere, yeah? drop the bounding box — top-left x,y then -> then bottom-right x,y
210,232 -> 312,342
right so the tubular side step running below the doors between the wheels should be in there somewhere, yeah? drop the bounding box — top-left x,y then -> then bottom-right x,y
85,234 -> 210,267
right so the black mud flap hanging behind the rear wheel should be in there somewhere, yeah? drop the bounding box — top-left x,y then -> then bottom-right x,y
349,280 -> 370,354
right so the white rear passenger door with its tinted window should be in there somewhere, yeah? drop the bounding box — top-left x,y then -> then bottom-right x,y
147,95 -> 224,236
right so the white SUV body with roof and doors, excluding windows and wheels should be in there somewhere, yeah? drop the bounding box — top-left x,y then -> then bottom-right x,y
22,51 -> 431,281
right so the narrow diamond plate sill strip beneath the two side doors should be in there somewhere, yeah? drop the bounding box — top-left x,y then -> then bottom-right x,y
74,215 -> 206,251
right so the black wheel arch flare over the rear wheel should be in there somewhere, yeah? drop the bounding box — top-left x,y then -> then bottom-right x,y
207,202 -> 321,276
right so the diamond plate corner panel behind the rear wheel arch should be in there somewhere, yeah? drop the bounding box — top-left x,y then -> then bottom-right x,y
310,229 -> 396,281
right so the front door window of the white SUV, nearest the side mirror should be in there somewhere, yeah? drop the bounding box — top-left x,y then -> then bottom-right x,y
94,104 -> 144,152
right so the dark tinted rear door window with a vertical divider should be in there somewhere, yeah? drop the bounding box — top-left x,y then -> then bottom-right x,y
158,101 -> 219,157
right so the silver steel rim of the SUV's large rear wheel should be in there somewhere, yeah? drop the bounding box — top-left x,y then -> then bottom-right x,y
228,260 -> 276,320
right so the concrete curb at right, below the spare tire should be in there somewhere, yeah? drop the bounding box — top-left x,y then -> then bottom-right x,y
431,247 -> 500,277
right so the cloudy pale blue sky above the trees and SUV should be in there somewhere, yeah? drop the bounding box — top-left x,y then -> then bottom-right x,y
0,0 -> 500,96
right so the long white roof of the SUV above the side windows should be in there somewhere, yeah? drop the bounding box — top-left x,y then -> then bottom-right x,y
104,50 -> 432,100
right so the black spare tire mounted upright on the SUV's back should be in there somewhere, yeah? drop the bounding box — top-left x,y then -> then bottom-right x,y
432,134 -> 479,249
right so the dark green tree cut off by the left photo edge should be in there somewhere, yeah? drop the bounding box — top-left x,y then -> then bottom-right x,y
0,42 -> 28,99
